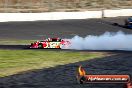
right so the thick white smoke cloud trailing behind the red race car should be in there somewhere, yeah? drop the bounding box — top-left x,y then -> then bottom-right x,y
63,31 -> 132,50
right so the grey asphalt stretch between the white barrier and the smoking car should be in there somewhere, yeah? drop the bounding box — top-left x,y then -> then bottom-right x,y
0,17 -> 132,40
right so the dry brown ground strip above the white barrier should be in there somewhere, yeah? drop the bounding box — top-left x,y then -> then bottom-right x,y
0,0 -> 132,12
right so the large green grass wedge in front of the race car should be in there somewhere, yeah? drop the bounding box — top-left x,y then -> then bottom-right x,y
0,50 -> 103,77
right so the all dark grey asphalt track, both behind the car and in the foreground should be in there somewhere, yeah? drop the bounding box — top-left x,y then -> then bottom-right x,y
0,17 -> 132,88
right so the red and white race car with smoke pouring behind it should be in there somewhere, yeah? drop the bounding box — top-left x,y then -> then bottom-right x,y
30,38 -> 70,49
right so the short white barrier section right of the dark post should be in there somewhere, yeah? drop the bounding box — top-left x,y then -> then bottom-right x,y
103,9 -> 132,17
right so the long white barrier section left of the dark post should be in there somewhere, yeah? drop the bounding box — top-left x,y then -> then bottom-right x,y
0,11 -> 102,22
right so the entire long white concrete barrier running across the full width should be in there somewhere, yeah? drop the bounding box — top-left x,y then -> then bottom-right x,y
0,9 -> 132,22
